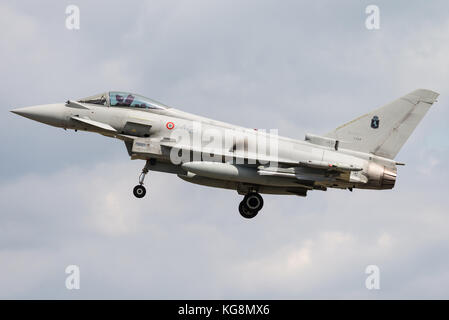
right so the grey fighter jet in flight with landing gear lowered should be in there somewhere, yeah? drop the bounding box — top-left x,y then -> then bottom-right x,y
11,89 -> 438,219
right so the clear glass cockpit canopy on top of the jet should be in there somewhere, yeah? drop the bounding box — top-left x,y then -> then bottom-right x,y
78,91 -> 168,110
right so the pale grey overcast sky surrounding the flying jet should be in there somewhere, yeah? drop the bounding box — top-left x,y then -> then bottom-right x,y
0,0 -> 449,299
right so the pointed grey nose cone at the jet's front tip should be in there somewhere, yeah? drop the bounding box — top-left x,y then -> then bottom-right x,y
11,103 -> 67,127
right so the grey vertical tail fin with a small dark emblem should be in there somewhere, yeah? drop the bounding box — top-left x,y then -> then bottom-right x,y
325,89 -> 439,159
